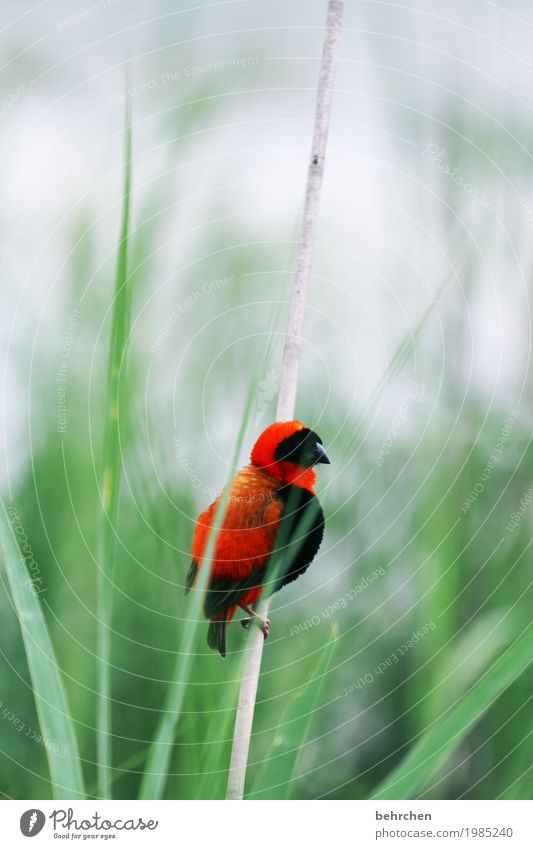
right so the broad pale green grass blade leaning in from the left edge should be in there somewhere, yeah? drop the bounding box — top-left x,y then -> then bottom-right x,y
0,496 -> 85,799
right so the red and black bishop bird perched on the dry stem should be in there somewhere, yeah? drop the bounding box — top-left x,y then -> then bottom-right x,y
185,421 -> 329,657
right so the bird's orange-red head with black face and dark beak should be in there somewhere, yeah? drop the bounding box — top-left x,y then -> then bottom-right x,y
250,421 -> 329,492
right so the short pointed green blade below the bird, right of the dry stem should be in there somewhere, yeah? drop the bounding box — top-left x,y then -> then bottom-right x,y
246,626 -> 337,799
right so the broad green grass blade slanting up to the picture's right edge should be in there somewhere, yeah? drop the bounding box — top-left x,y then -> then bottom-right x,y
371,627 -> 533,799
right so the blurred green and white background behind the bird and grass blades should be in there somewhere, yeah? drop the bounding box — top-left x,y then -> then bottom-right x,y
0,0 -> 533,799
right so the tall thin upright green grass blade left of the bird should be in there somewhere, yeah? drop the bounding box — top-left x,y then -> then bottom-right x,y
96,100 -> 131,799
